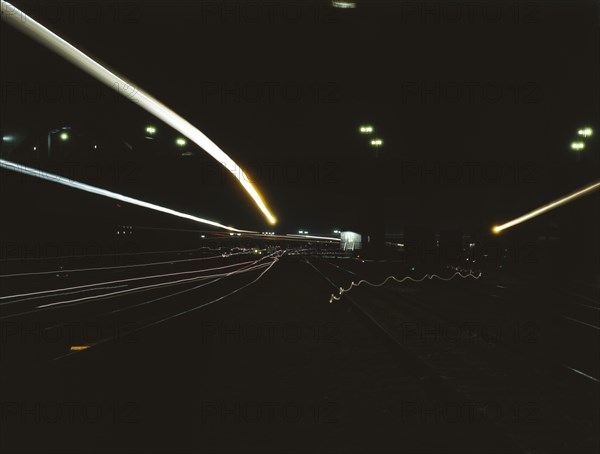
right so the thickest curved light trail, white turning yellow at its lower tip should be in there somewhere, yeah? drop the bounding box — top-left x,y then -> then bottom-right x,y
2,0 -> 277,224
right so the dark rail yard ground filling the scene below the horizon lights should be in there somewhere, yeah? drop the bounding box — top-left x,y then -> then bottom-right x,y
0,250 -> 600,453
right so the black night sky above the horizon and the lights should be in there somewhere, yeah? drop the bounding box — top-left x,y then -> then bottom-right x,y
1,0 -> 600,232
